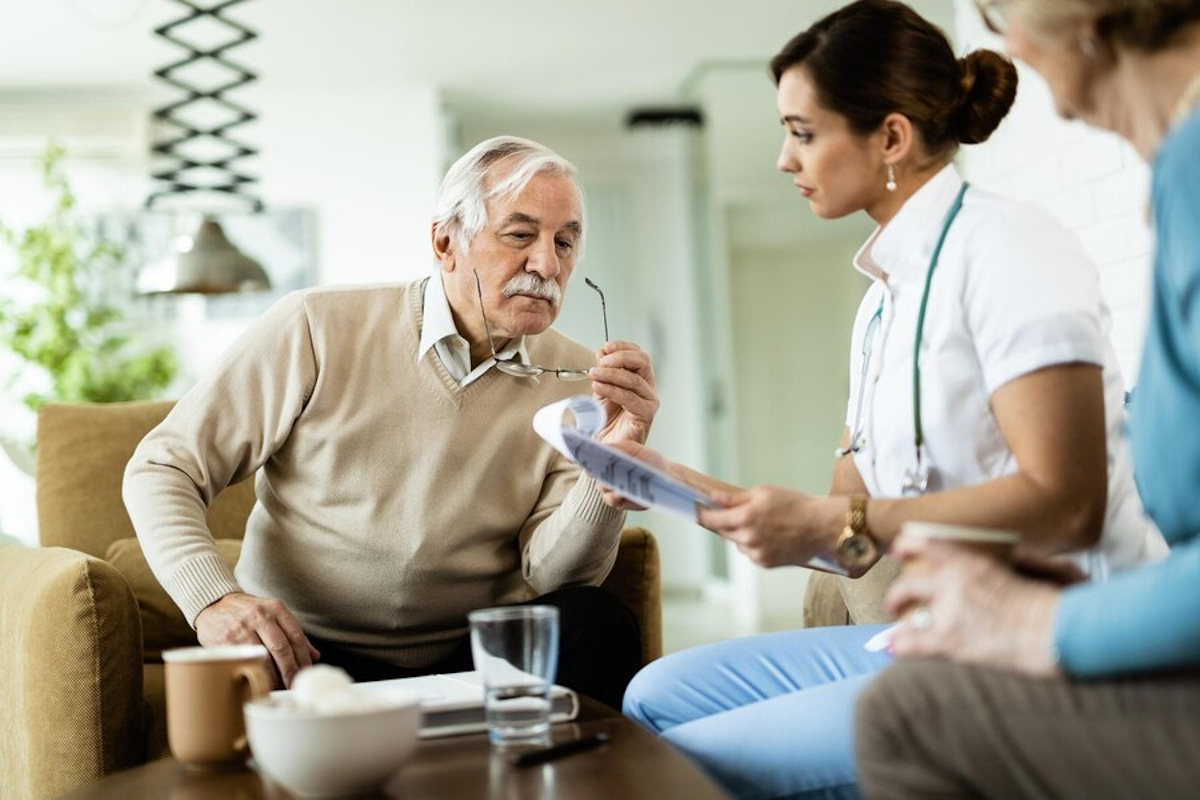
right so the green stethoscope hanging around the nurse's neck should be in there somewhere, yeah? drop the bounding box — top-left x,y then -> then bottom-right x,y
834,182 -> 970,495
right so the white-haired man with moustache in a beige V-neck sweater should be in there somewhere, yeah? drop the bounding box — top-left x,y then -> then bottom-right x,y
124,137 -> 659,708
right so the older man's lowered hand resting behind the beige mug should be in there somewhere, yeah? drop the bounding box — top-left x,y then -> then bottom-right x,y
196,593 -> 320,688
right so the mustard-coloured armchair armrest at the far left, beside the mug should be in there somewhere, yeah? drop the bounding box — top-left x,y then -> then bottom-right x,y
0,543 -> 145,799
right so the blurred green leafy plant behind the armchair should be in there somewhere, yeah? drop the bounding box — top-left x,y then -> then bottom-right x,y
0,144 -> 176,470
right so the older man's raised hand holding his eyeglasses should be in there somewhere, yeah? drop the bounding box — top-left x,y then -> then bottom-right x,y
592,342 -> 659,445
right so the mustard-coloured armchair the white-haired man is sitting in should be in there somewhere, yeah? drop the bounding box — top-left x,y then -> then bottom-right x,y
0,403 -> 662,800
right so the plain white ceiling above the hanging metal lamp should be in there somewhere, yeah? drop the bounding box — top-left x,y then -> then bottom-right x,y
0,0 -> 953,113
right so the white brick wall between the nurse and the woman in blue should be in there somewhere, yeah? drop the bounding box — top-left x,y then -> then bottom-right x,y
955,0 -> 1153,386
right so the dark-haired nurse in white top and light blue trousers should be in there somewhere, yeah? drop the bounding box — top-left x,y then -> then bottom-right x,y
624,0 -> 1164,798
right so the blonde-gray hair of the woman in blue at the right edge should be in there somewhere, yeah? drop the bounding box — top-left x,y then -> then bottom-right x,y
1012,0 -> 1200,52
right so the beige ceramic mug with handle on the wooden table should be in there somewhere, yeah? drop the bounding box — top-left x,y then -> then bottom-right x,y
162,644 -> 271,770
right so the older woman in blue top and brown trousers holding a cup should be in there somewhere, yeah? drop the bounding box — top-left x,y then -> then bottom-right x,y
856,0 -> 1200,798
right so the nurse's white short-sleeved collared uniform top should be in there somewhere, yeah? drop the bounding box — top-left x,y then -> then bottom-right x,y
846,166 -> 1165,577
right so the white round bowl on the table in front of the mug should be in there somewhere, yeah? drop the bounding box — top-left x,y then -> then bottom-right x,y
245,697 -> 421,798
